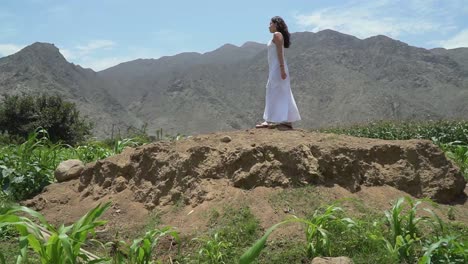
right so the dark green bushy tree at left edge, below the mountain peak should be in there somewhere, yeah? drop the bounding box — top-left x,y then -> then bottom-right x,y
0,94 -> 92,145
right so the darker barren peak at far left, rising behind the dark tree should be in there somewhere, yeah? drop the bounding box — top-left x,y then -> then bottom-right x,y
0,43 -> 141,137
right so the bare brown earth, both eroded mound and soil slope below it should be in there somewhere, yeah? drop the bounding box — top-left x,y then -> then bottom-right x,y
25,129 -> 468,239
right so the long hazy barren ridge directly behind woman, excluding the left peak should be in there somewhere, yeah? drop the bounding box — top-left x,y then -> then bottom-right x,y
99,30 -> 468,133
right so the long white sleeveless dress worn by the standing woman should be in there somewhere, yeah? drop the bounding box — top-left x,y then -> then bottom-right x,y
263,40 -> 301,123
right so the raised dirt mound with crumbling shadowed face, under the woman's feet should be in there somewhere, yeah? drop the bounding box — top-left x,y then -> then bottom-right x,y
28,129 -> 466,209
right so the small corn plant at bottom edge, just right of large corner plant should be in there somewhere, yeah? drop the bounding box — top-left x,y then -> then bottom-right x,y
104,227 -> 180,264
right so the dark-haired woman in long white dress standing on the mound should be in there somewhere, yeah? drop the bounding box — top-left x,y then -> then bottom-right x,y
256,16 -> 301,129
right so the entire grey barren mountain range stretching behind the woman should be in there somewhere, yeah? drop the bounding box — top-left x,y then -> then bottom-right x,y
0,30 -> 468,137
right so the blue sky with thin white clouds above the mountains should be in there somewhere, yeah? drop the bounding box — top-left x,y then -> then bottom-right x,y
0,0 -> 468,71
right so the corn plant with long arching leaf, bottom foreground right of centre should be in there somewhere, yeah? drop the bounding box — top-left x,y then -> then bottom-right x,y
239,205 -> 355,264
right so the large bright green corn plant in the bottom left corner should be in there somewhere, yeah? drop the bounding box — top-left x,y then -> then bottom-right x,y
0,203 -> 110,264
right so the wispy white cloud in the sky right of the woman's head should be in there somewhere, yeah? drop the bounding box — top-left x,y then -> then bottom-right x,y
295,0 -> 453,38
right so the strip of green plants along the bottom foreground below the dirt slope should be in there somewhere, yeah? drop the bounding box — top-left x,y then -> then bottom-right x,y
0,198 -> 468,264
